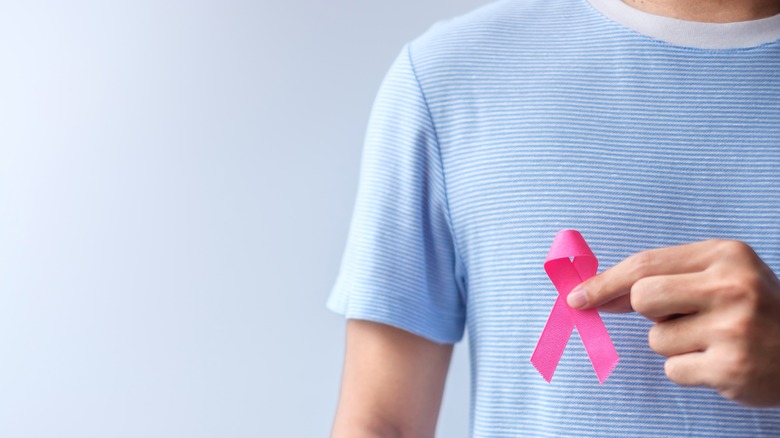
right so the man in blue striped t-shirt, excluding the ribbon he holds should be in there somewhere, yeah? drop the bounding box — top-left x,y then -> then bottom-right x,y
328,0 -> 780,437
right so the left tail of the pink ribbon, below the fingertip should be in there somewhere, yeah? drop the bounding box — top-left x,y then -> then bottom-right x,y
531,295 -> 574,383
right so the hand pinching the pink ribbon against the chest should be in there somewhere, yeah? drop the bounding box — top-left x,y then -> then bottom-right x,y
568,240 -> 780,406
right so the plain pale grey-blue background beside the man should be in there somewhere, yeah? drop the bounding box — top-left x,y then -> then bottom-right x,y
0,0 -> 486,438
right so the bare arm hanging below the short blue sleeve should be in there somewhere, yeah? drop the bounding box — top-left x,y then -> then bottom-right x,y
333,319 -> 452,438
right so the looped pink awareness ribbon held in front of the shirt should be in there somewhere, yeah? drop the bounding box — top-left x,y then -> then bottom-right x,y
531,230 -> 619,383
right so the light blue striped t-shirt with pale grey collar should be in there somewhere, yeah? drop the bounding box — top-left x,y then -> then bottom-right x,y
328,0 -> 780,438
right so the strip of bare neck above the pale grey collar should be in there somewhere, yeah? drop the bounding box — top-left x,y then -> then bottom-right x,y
623,0 -> 780,23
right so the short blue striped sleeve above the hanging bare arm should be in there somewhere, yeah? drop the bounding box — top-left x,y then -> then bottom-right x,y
328,46 -> 466,343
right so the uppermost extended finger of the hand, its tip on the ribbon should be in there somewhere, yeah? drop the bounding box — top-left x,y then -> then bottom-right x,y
568,241 -> 713,310
